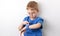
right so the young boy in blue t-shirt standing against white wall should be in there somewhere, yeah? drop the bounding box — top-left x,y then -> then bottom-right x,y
19,1 -> 43,36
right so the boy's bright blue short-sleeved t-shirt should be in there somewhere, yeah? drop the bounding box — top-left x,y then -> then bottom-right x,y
23,16 -> 44,36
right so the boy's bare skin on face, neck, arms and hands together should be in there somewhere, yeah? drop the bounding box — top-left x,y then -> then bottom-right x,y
18,7 -> 41,36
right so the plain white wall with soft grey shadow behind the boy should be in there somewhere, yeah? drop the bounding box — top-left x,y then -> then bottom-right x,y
0,0 -> 60,36
